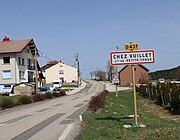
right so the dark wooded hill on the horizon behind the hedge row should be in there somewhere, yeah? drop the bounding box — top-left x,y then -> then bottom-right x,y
149,66 -> 180,80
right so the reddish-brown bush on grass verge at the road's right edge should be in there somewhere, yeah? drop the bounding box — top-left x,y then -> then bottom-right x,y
89,90 -> 109,112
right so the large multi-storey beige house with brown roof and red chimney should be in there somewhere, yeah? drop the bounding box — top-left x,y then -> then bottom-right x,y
0,36 -> 43,92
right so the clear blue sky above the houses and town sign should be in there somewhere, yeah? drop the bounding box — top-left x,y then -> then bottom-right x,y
0,0 -> 180,78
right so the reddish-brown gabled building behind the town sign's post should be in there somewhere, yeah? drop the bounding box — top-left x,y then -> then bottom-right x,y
119,65 -> 149,86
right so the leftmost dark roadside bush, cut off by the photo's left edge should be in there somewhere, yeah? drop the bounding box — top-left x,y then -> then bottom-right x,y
0,98 -> 16,109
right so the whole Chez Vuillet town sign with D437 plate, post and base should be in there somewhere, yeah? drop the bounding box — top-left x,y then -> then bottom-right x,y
110,43 -> 155,128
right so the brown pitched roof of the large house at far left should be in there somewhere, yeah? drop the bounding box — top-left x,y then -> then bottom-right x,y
0,39 -> 38,55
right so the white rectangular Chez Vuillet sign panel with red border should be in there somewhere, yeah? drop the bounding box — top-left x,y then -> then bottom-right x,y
110,50 -> 154,66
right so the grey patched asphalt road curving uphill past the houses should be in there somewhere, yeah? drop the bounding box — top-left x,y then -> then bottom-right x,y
0,80 -> 104,140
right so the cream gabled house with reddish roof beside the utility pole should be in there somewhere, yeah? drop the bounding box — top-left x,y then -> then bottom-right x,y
41,61 -> 78,84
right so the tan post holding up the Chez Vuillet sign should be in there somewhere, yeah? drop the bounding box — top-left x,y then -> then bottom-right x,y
131,65 -> 137,124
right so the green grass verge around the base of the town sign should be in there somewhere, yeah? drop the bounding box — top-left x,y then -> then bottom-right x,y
76,91 -> 180,140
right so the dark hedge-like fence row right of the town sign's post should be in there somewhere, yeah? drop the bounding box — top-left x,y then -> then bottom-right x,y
137,83 -> 180,115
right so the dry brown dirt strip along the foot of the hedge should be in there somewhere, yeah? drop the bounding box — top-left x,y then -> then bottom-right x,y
139,99 -> 180,122
